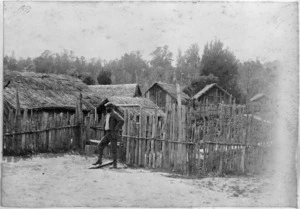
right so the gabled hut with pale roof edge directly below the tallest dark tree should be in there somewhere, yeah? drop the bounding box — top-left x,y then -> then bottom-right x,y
192,83 -> 235,106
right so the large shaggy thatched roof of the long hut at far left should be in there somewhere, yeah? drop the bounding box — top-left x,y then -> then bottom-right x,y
3,71 -> 103,110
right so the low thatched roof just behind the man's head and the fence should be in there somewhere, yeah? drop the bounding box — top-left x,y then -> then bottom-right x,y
100,96 -> 164,116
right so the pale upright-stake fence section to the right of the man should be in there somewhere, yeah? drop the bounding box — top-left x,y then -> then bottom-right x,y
113,104 -> 273,175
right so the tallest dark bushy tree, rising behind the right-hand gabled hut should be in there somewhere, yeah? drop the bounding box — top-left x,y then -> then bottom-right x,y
200,40 -> 241,101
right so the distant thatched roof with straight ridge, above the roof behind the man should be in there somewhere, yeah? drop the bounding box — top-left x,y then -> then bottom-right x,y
89,84 -> 142,98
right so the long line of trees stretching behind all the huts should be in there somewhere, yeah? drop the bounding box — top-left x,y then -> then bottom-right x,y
3,40 -> 279,103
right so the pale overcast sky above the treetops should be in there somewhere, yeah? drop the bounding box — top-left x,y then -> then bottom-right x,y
4,2 -> 298,62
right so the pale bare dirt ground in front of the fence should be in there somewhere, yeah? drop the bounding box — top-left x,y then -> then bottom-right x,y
2,154 -> 294,207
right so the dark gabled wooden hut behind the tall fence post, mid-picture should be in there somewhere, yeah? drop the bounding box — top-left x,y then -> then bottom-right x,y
145,82 -> 190,111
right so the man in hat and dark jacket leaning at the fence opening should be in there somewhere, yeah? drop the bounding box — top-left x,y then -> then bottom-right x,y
93,102 -> 124,168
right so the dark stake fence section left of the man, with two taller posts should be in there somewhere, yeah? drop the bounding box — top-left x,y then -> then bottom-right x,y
3,93 -> 88,155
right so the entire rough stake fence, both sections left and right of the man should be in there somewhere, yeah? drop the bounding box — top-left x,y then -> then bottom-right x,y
3,91 -> 274,175
